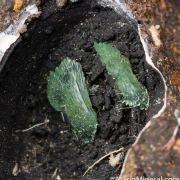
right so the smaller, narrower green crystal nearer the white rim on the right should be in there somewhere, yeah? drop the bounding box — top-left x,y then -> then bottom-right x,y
94,43 -> 149,109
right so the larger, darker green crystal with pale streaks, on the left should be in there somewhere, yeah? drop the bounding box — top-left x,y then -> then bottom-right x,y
47,58 -> 97,144
